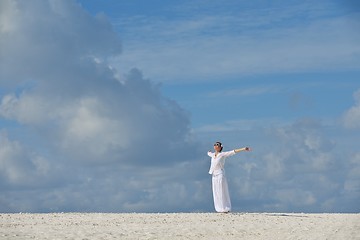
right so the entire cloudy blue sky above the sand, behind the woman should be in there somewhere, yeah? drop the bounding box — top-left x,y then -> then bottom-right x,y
0,0 -> 360,212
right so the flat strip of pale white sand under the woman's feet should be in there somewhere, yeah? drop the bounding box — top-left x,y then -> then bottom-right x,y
0,213 -> 360,240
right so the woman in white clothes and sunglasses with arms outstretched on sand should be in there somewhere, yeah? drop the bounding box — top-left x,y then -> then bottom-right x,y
208,142 -> 250,213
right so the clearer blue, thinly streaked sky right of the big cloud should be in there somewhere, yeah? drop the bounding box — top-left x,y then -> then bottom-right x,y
82,1 -> 359,126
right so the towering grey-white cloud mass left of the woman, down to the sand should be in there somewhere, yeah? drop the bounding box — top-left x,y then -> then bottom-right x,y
0,0 -> 205,214
